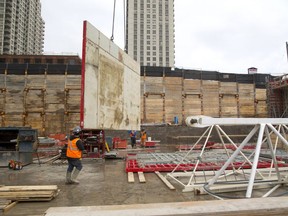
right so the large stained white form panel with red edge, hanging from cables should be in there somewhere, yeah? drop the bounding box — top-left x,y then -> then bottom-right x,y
80,21 -> 140,130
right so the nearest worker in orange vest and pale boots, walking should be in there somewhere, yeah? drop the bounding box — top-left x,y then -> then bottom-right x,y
66,126 -> 85,184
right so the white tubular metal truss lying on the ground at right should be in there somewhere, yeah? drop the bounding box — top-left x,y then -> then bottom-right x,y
166,116 -> 288,199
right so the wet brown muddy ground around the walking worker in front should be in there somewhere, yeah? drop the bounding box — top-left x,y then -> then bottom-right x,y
0,145 -> 214,216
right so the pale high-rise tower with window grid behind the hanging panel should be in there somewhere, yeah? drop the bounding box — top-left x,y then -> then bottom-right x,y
125,0 -> 175,67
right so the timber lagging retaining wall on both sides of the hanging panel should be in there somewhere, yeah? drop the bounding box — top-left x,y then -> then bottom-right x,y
0,64 -> 268,136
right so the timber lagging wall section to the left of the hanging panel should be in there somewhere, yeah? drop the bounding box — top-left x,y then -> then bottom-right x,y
0,65 -> 81,136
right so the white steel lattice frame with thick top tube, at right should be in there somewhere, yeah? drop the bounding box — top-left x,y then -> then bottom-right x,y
166,116 -> 288,199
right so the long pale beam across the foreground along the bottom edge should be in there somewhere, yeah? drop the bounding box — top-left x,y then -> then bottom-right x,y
45,197 -> 288,216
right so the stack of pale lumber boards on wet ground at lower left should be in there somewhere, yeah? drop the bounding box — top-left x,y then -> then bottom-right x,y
0,185 -> 59,201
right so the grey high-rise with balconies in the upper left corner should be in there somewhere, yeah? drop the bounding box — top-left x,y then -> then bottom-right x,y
0,0 -> 45,55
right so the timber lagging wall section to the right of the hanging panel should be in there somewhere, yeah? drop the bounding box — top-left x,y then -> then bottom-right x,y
141,67 -> 270,124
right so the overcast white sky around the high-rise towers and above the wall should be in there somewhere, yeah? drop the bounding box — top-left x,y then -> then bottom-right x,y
41,0 -> 288,75
